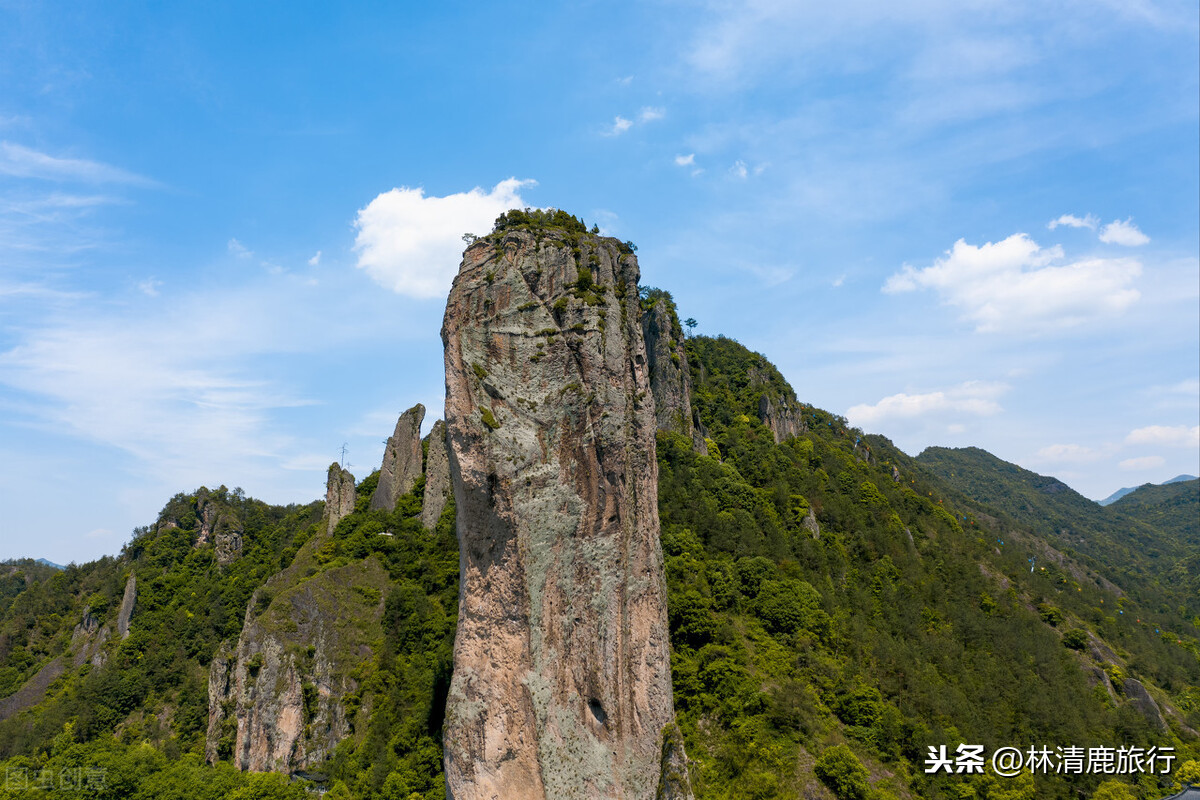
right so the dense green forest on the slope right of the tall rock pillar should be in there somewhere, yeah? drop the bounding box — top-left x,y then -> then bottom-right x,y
659,338 -> 1200,798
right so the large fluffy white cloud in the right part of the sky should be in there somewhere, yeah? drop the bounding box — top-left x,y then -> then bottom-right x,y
883,234 -> 1141,333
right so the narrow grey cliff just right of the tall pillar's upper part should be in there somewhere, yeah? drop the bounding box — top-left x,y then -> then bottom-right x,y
642,297 -> 708,453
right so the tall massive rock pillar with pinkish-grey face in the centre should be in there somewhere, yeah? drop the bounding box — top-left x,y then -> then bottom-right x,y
442,225 -> 690,800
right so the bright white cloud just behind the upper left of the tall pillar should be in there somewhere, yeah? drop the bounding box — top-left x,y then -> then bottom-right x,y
354,178 -> 536,299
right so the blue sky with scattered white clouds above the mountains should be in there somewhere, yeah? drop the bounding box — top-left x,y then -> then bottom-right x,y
0,0 -> 1200,564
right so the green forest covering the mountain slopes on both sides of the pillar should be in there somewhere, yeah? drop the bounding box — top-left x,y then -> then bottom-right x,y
0,297 -> 1200,800
